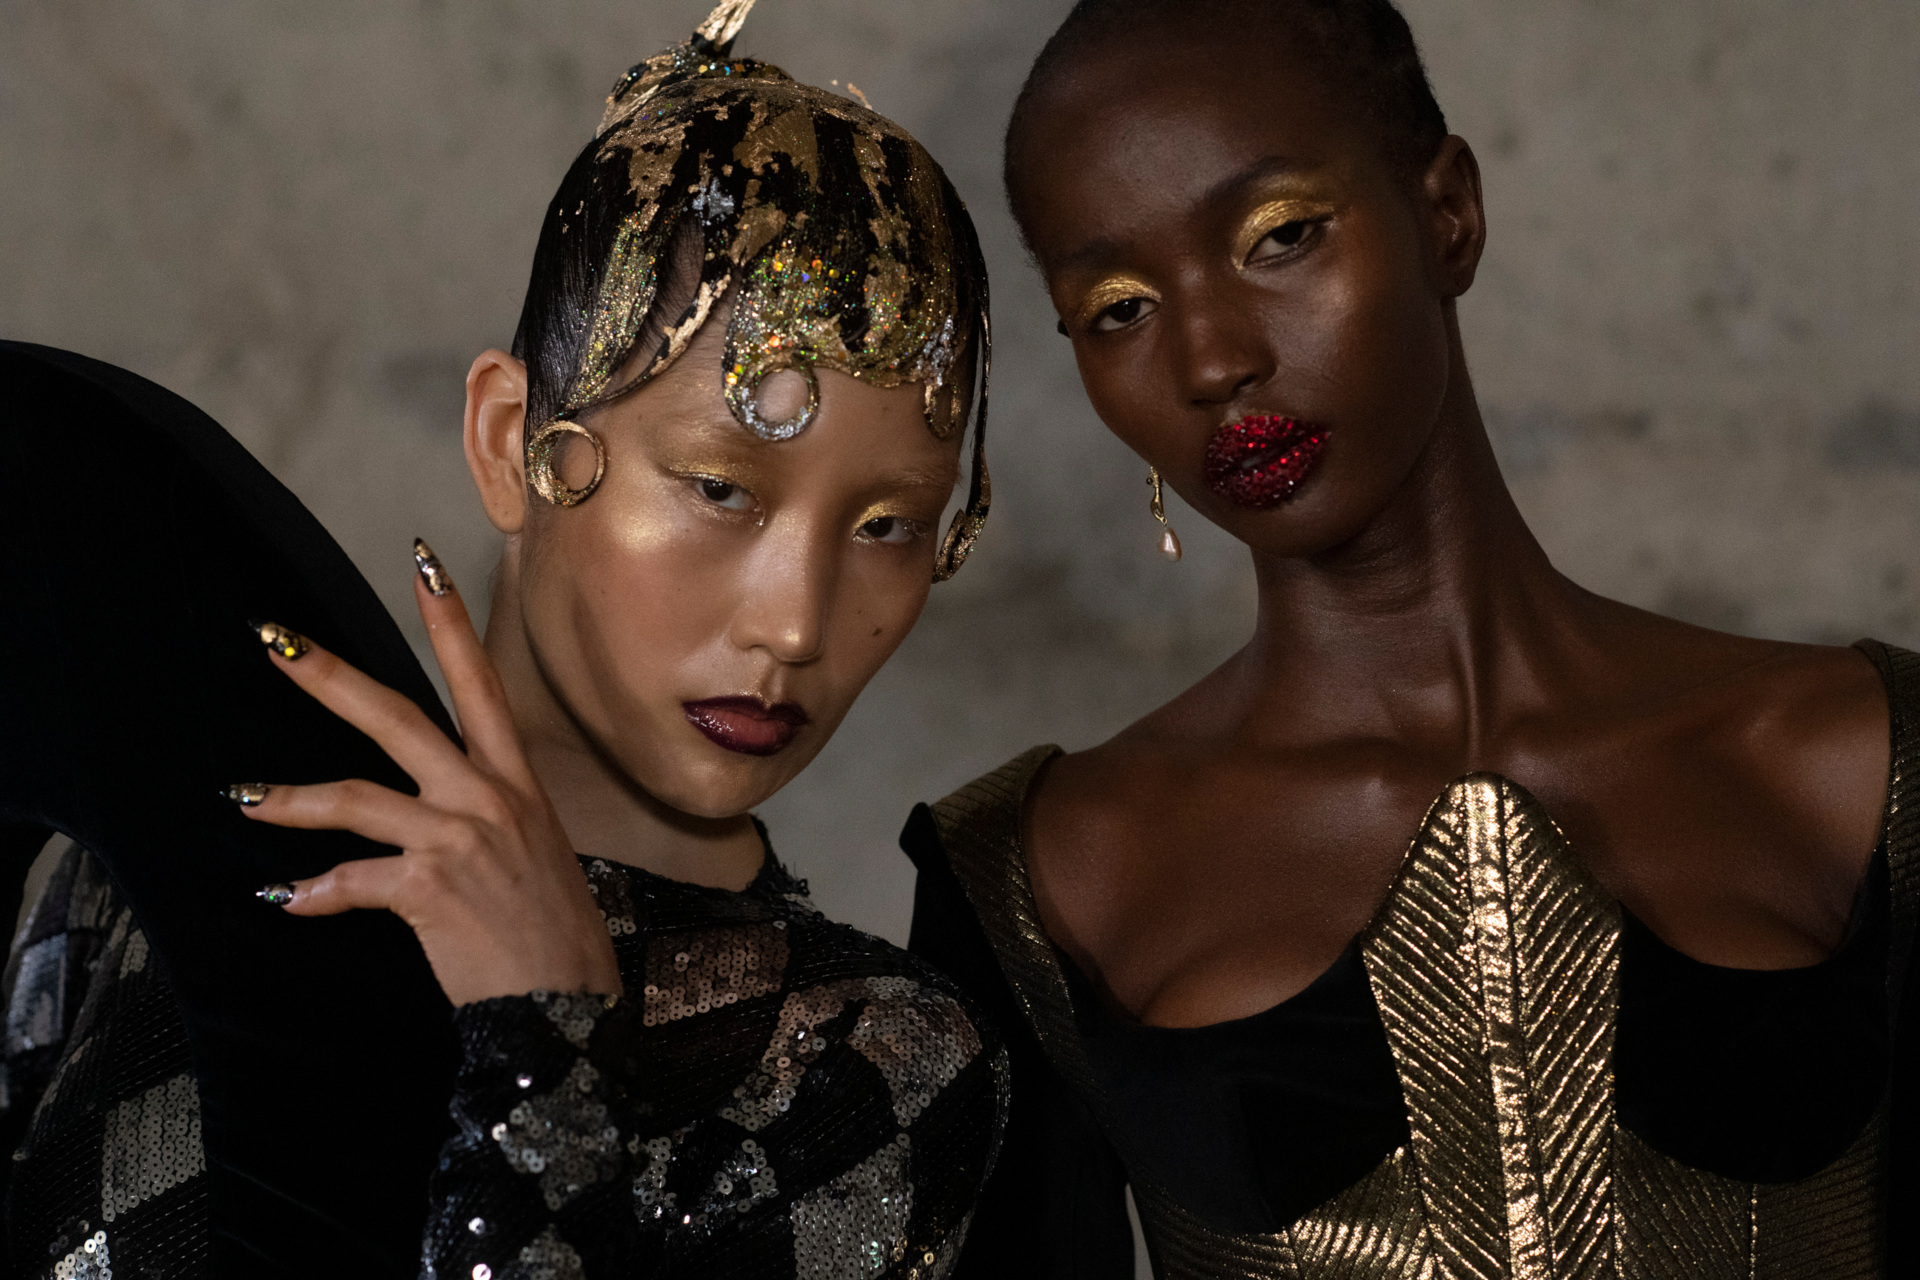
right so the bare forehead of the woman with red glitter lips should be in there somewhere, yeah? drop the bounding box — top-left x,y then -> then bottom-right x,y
1014,33 -> 1379,255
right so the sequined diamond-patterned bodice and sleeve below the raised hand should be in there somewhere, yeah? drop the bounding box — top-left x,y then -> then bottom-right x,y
424,854 -> 1006,1280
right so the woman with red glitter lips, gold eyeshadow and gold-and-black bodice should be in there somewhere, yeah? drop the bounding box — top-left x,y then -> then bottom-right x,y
902,0 -> 1920,1278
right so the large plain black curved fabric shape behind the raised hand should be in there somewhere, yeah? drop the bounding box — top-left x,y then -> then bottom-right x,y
0,342 -> 457,1276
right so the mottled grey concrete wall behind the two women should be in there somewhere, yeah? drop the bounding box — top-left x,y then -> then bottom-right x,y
0,0 -> 1920,951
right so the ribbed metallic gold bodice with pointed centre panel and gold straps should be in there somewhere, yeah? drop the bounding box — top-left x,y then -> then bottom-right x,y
933,645 -> 1920,1280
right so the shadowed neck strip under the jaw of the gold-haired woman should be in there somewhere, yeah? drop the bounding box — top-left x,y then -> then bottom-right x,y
486,543 -> 764,889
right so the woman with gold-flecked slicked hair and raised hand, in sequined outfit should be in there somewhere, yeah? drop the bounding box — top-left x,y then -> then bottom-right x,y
6,0 -> 1004,1280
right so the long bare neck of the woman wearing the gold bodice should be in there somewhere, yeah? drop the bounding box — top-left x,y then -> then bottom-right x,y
1238,328 -> 1599,768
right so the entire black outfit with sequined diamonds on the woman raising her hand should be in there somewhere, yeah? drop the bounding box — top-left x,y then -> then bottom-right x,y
0,342 -> 1004,1280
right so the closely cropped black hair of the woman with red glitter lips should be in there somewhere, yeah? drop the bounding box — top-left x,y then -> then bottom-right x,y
1002,0 -> 1448,230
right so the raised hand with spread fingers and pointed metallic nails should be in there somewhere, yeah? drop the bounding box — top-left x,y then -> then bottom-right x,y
234,543 -> 620,1004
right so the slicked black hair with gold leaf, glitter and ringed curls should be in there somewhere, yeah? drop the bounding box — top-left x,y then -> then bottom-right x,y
528,0 -> 989,580
